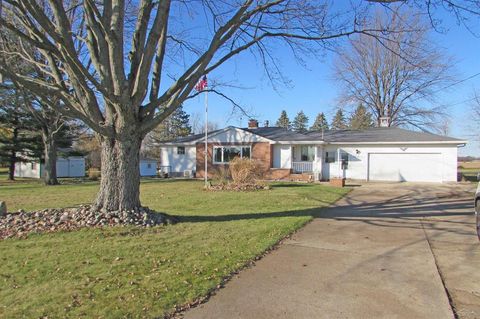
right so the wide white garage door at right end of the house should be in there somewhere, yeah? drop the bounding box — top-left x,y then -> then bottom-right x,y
368,153 -> 442,182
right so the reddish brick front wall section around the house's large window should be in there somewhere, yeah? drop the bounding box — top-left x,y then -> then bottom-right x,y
196,142 -> 273,178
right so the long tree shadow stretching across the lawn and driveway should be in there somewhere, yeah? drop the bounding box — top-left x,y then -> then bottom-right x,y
175,191 -> 475,236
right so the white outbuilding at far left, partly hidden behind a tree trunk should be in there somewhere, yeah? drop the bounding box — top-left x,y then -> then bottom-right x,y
15,156 -> 85,178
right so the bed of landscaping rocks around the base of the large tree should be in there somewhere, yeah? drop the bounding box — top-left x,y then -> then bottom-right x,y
0,206 -> 176,239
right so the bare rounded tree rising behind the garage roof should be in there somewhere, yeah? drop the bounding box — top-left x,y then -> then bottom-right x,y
334,11 -> 450,129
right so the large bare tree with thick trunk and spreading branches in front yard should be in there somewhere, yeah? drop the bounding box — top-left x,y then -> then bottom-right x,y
0,0 -> 392,210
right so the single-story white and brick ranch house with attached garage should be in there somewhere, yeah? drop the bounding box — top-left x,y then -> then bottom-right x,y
160,120 -> 466,182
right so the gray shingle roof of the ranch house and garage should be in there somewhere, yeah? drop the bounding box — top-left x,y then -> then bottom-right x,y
160,127 -> 464,144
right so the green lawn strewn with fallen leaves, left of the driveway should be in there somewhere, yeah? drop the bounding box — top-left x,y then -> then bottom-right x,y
0,180 -> 348,318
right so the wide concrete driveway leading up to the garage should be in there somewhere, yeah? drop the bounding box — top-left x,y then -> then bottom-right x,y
185,183 -> 480,319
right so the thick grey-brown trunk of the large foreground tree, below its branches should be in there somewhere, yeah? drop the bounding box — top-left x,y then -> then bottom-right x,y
94,134 -> 142,211
